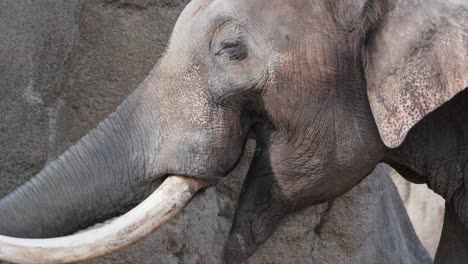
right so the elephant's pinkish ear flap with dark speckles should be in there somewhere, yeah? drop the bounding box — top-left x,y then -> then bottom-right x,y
362,0 -> 468,148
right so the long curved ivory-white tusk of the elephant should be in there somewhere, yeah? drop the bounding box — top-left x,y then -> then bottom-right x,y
0,176 -> 206,264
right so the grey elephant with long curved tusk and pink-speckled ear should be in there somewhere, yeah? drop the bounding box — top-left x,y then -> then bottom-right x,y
0,0 -> 468,263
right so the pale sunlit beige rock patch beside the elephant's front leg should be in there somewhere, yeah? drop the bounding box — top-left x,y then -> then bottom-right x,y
390,170 -> 445,257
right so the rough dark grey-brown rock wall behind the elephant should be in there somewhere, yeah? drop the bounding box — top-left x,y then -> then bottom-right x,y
0,0 -> 430,264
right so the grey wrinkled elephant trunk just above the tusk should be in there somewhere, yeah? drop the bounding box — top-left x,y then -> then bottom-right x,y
0,84 -> 159,238
